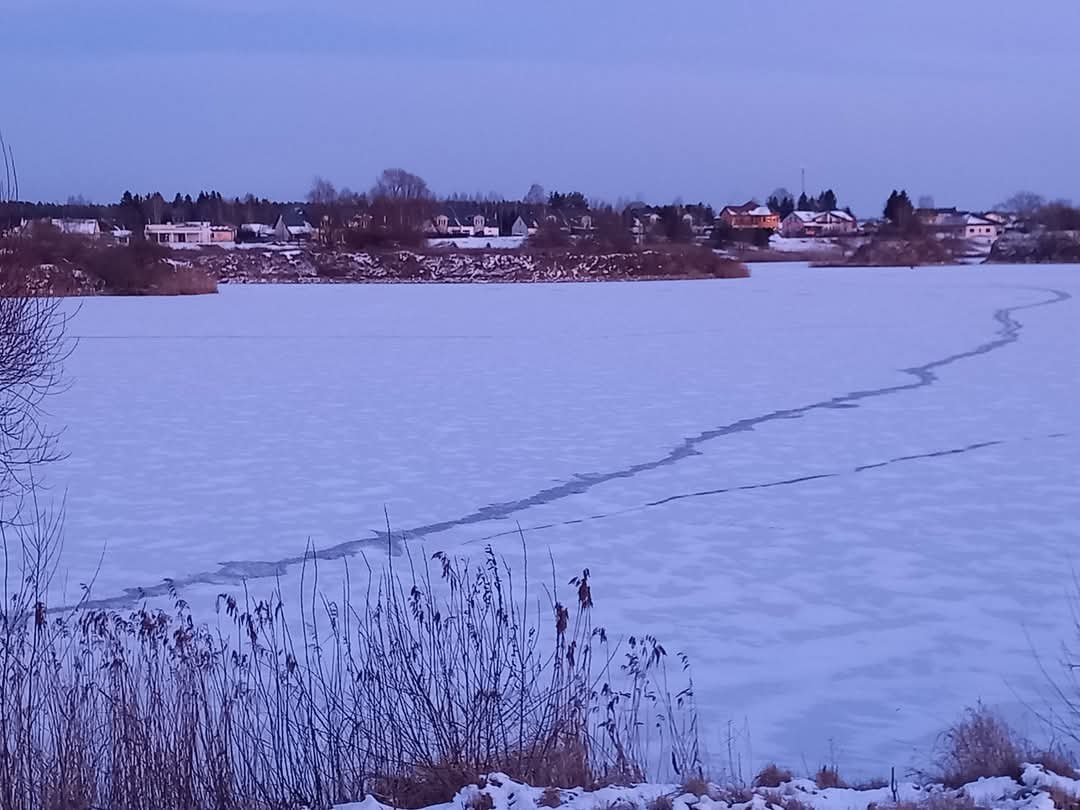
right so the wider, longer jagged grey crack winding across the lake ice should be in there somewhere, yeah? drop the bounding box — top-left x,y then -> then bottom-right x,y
69,287 -> 1072,608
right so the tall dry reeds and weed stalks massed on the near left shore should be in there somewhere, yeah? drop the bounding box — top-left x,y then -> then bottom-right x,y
0,507 -> 700,810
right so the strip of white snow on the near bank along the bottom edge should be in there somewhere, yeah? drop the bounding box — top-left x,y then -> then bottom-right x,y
337,766 -> 1080,810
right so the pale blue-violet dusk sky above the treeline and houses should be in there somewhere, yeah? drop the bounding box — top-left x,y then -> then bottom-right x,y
8,0 -> 1080,215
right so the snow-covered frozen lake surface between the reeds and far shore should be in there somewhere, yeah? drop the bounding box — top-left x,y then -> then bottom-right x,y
42,266 -> 1080,774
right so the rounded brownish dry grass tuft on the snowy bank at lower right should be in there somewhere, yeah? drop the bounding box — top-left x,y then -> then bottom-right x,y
936,705 -> 1026,787
